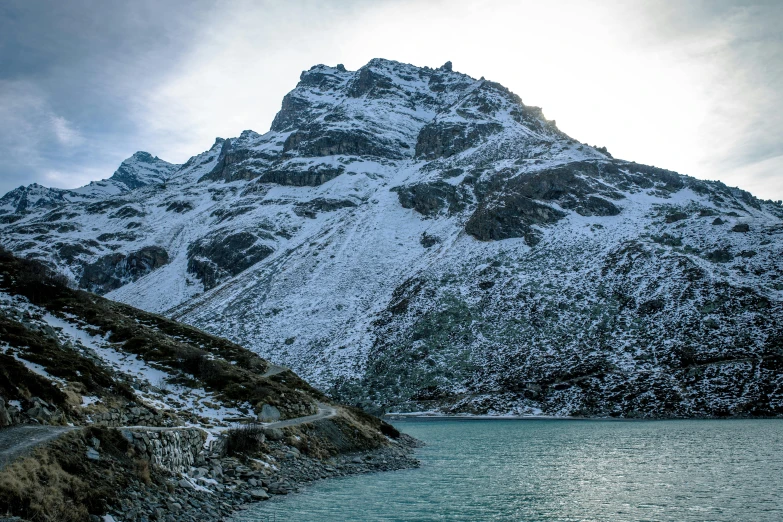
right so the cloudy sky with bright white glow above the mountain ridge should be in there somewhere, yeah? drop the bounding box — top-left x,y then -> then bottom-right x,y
0,0 -> 783,200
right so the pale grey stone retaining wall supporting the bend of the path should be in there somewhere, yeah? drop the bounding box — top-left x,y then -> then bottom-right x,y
121,428 -> 207,473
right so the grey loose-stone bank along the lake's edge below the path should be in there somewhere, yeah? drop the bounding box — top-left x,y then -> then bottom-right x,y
105,434 -> 422,522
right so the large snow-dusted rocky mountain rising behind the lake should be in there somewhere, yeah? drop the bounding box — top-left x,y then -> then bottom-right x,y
0,59 -> 783,417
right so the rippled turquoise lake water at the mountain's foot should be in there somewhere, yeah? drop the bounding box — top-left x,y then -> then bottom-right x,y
235,420 -> 783,522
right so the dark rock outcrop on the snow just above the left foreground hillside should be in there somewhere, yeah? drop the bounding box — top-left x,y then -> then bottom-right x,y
79,246 -> 169,294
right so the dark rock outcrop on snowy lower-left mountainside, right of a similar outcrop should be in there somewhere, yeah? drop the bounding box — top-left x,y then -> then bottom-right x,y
188,232 -> 274,290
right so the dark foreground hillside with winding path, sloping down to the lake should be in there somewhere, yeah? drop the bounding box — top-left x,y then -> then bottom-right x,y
0,250 -> 417,522
